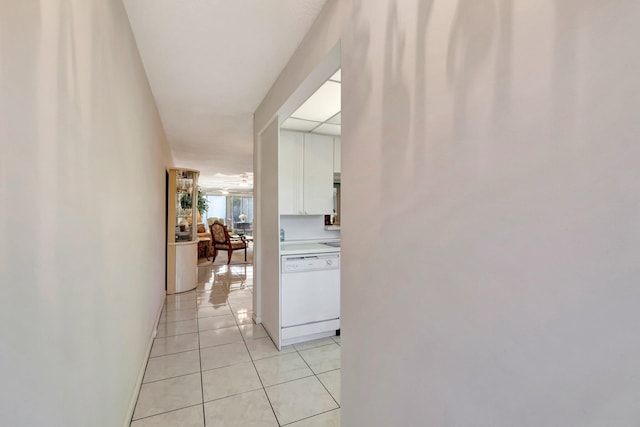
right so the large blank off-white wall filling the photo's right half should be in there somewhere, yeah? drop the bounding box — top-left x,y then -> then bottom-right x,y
341,0 -> 640,427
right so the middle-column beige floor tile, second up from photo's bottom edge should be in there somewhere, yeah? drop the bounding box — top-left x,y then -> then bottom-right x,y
202,362 -> 262,402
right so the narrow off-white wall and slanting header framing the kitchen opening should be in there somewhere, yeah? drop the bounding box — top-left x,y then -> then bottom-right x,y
253,1 -> 350,321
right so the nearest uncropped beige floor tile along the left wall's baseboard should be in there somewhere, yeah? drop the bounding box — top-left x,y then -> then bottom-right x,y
133,373 -> 202,420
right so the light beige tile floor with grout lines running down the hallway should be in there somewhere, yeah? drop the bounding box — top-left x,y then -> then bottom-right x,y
131,264 -> 340,427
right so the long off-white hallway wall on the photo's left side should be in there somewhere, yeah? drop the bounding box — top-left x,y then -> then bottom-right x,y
0,0 -> 171,426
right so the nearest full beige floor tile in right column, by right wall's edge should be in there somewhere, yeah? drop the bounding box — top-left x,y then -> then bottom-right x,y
266,377 -> 338,425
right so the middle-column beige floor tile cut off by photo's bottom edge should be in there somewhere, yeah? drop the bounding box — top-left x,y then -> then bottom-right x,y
204,390 -> 278,427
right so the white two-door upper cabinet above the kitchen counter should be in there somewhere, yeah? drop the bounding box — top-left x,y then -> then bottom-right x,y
278,131 -> 334,215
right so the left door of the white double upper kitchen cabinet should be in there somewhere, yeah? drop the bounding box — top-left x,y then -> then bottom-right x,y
278,131 -> 304,215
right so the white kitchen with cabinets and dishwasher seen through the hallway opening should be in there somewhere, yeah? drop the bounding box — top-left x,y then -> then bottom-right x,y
256,66 -> 341,349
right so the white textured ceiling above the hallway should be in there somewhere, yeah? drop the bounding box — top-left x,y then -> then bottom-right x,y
124,0 -> 326,188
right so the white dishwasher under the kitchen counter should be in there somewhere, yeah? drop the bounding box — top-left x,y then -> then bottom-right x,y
280,252 -> 340,345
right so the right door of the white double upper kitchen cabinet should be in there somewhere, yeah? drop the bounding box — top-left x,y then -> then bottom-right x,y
303,133 -> 333,215
